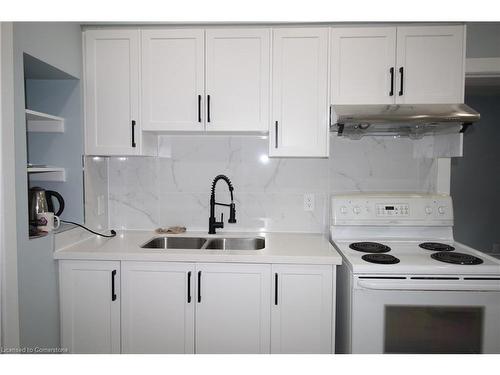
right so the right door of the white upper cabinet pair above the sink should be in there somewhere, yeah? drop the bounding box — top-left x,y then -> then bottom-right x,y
206,29 -> 271,132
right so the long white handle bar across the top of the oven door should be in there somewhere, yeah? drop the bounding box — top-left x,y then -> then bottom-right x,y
357,279 -> 500,292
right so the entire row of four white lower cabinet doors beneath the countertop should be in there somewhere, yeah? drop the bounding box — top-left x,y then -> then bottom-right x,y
60,260 -> 335,353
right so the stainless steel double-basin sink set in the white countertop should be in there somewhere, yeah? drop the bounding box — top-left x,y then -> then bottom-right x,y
141,237 -> 266,250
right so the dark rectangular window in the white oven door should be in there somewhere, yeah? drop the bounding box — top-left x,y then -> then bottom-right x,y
384,306 -> 484,354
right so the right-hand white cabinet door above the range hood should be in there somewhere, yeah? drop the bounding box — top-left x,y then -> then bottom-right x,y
396,26 -> 465,104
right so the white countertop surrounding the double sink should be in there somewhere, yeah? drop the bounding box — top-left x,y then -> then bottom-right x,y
54,229 -> 342,265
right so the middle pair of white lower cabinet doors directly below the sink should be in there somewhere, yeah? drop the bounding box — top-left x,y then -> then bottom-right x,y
122,262 -> 271,353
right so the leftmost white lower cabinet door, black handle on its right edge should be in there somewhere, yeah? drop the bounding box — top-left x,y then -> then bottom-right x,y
59,261 -> 120,353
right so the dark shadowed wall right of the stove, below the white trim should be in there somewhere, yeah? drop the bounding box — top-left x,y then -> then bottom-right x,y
451,94 -> 500,252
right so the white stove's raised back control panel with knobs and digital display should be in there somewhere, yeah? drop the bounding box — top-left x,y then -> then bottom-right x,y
332,194 -> 453,226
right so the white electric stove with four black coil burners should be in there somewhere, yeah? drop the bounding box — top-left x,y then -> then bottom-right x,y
331,194 -> 500,353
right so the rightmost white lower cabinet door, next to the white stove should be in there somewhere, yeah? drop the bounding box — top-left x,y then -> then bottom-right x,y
271,265 -> 334,353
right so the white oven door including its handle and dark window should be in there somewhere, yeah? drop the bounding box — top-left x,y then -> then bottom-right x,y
351,276 -> 500,353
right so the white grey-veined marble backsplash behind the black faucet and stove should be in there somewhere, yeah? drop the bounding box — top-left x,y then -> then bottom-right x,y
85,134 -> 437,232
